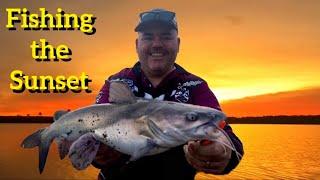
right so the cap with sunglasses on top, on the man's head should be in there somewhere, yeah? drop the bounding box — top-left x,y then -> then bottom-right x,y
134,9 -> 178,32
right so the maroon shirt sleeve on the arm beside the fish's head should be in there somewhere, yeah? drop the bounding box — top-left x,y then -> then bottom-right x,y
192,82 -> 244,174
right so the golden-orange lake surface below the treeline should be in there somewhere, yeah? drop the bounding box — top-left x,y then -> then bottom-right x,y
0,124 -> 320,180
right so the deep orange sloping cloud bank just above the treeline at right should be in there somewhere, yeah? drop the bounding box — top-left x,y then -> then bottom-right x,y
221,87 -> 320,117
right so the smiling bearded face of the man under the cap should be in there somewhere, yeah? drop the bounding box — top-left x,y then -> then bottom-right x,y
136,26 -> 180,76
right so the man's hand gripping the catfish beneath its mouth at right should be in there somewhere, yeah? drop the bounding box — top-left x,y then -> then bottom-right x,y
183,136 -> 231,174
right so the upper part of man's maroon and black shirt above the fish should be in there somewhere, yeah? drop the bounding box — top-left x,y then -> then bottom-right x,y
96,64 -> 221,110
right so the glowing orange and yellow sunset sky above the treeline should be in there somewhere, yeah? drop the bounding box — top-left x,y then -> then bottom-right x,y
0,0 -> 320,116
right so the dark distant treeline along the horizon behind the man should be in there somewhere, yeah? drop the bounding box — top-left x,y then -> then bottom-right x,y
0,115 -> 320,124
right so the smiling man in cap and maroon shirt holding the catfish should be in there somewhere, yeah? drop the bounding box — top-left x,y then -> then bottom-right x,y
93,9 -> 243,180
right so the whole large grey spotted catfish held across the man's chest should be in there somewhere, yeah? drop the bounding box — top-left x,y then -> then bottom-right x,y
21,82 -> 234,173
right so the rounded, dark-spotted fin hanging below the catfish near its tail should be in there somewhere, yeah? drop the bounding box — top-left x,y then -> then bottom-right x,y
69,133 -> 100,170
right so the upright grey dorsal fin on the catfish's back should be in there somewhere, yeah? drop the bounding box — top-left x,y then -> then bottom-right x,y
109,82 -> 137,104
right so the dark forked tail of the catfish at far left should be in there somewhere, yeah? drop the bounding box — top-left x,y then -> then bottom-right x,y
21,128 -> 52,174
